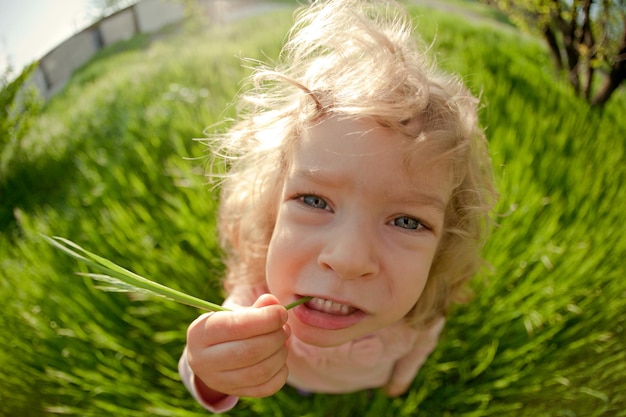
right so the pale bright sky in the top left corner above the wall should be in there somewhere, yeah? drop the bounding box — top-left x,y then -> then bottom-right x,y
0,0 -> 93,74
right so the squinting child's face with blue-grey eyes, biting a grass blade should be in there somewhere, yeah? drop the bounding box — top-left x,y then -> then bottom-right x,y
267,118 -> 452,346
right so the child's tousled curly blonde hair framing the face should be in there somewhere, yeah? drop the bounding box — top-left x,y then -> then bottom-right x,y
208,0 -> 495,326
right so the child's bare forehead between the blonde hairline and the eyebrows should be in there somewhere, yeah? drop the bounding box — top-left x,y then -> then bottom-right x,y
290,117 -> 451,201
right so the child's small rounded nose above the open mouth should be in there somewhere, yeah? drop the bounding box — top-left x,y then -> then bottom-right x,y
318,214 -> 380,279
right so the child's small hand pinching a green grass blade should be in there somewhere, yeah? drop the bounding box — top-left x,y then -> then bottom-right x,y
187,294 -> 290,403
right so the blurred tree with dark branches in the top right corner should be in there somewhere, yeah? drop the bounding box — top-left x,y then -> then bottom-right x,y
482,0 -> 626,106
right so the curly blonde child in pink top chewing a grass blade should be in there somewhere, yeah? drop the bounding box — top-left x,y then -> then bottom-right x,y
179,0 -> 493,412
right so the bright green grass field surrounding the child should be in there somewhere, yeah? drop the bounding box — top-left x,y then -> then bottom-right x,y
0,1 -> 626,417
